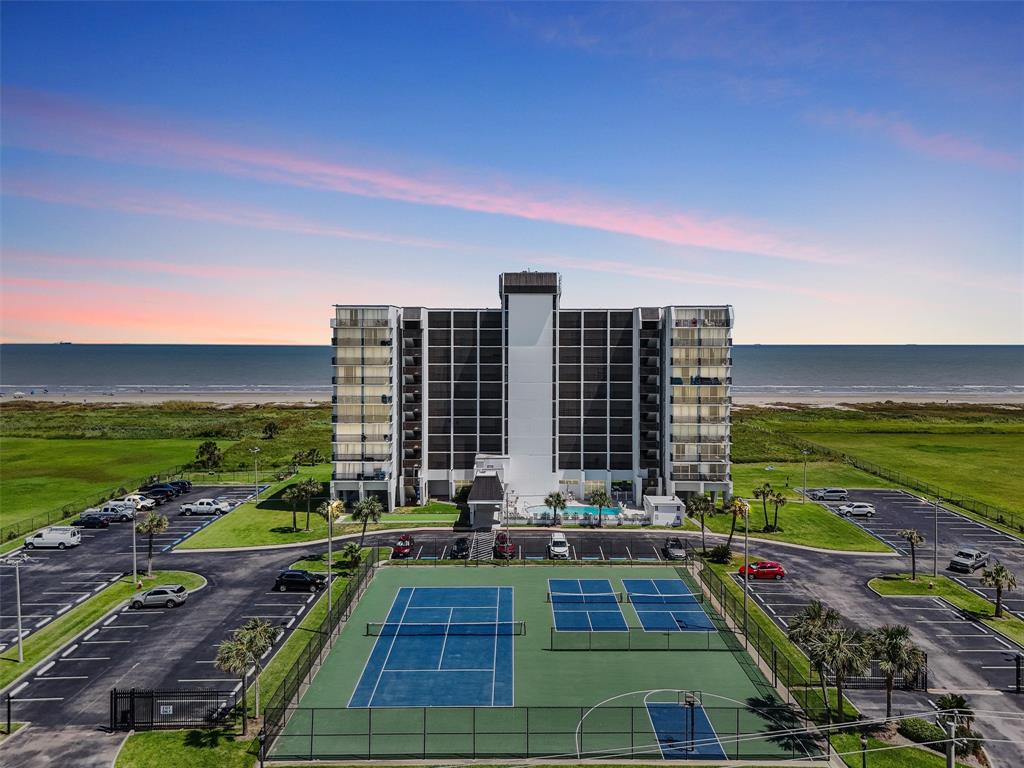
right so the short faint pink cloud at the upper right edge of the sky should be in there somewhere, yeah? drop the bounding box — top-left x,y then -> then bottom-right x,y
807,110 -> 1024,172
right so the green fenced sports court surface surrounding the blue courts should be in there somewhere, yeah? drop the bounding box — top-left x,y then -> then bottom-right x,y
270,565 -> 819,761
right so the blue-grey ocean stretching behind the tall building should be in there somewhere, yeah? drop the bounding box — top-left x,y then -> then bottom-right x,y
0,344 -> 1024,399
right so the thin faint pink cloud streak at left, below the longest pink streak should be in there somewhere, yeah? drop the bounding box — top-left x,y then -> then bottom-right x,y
2,174 -> 455,248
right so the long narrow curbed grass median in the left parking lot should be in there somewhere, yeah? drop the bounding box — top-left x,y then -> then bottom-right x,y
0,570 -> 206,688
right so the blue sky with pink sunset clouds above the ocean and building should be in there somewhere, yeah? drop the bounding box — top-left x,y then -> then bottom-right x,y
0,2 -> 1024,344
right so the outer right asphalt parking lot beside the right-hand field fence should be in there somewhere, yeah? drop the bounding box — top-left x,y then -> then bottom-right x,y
824,489 -> 1024,616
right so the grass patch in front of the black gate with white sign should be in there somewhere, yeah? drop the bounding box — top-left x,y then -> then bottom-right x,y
114,728 -> 256,768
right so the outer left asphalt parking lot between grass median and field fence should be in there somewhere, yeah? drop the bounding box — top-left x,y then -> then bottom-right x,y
0,485 -> 254,653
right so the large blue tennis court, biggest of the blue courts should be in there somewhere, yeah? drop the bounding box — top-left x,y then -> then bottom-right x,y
348,587 -> 513,707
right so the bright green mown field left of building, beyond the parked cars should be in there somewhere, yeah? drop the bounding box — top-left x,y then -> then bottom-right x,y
0,438 -> 207,525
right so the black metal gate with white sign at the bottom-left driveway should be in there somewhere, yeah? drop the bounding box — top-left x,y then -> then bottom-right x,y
111,688 -> 238,731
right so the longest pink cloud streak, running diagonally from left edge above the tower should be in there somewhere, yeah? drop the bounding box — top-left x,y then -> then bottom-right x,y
4,89 -> 838,263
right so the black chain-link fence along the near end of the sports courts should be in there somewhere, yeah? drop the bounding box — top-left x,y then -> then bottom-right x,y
268,699 -> 826,761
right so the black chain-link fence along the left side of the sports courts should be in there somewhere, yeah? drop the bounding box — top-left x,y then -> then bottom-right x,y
263,547 -> 381,743
